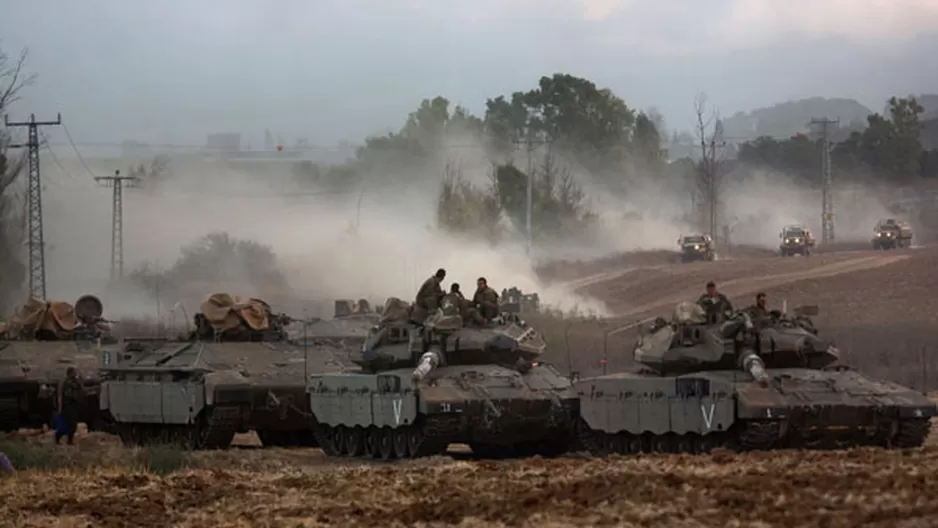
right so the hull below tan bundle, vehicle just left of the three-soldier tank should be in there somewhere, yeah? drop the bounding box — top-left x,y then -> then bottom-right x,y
98,341 -> 347,449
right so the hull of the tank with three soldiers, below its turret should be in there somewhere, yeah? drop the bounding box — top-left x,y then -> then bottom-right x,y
309,365 -> 578,460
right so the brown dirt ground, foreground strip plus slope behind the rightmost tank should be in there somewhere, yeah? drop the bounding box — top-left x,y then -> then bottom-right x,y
0,244 -> 938,527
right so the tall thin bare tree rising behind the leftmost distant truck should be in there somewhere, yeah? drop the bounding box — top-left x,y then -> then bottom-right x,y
694,92 -> 726,243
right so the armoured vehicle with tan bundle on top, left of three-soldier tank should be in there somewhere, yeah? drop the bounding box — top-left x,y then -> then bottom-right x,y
100,294 -> 372,449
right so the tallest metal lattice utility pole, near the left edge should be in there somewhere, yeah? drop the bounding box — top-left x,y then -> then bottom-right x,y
4,114 -> 62,300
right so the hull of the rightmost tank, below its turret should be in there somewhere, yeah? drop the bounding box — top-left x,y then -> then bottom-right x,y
576,369 -> 938,453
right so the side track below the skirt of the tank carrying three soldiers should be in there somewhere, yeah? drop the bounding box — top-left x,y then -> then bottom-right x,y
313,422 -> 449,460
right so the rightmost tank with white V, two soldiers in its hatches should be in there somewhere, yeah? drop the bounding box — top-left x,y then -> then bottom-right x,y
576,303 -> 938,453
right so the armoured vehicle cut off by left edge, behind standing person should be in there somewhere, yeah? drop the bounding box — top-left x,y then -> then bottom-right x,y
0,295 -> 113,431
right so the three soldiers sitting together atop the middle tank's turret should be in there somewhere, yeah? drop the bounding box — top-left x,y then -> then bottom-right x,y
413,268 -> 499,325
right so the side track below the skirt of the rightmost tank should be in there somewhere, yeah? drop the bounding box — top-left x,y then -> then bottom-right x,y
578,420 -> 781,456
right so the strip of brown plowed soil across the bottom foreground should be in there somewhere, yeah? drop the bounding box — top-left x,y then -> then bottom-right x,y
0,447 -> 938,528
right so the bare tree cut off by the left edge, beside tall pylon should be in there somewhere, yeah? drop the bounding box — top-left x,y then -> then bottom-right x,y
0,49 -> 35,309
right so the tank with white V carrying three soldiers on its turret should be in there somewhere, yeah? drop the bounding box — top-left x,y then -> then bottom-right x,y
308,296 -> 578,460
